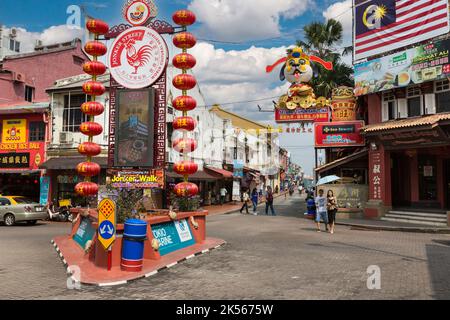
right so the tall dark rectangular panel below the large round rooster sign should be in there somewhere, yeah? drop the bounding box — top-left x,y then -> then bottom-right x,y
114,89 -> 155,168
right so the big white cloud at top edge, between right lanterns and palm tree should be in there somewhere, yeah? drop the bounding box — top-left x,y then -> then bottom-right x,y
189,0 -> 311,41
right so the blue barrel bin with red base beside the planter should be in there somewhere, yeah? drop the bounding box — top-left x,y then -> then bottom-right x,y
120,219 -> 147,272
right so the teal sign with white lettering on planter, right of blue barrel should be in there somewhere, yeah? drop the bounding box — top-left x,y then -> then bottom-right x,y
152,219 -> 195,256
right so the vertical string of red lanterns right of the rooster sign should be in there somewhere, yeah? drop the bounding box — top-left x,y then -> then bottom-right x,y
172,10 -> 199,197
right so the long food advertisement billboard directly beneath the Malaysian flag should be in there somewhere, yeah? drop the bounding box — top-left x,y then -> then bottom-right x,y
354,39 -> 450,96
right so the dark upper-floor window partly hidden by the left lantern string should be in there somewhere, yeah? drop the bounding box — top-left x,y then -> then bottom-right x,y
63,94 -> 90,132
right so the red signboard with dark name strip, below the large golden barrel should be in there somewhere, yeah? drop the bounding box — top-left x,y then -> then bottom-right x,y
314,121 -> 365,148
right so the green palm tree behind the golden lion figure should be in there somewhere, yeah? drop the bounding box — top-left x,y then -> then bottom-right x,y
297,19 -> 354,97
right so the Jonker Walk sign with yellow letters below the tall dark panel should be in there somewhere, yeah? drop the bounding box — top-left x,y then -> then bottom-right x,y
108,170 -> 164,189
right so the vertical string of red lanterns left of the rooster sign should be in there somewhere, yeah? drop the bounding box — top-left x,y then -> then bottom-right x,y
75,19 -> 109,197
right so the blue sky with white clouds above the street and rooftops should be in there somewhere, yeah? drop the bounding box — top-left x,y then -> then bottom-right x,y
0,0 -> 351,174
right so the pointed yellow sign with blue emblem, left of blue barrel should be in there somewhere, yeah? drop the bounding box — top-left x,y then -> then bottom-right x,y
98,199 -> 116,250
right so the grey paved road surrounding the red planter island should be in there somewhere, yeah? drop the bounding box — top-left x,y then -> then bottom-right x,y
0,196 -> 450,299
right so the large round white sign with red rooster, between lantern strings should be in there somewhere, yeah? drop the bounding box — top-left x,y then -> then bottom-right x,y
108,27 -> 169,89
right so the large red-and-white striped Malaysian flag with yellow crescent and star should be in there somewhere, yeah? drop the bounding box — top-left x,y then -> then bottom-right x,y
354,0 -> 450,60
